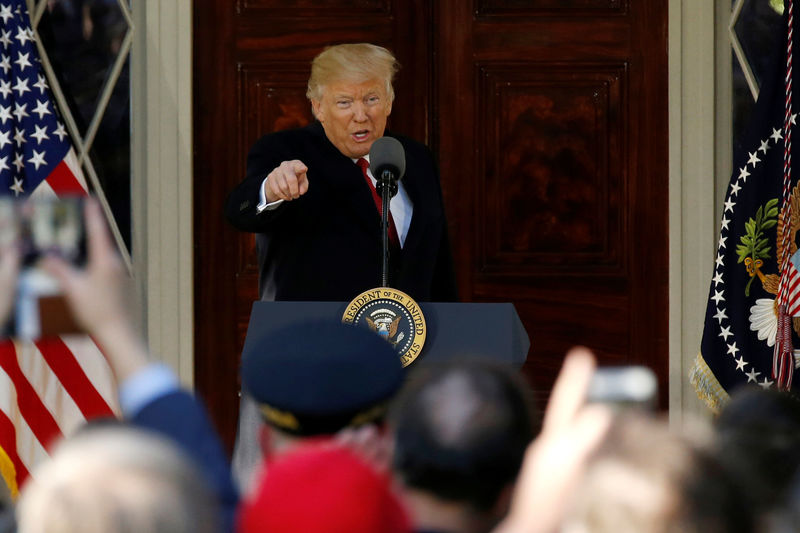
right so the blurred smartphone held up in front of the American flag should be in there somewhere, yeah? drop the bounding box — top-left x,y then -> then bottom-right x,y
0,197 -> 86,340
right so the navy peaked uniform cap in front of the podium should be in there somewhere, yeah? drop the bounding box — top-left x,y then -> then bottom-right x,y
242,321 -> 404,435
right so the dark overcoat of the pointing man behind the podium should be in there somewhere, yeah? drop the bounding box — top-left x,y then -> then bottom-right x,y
225,122 -> 457,301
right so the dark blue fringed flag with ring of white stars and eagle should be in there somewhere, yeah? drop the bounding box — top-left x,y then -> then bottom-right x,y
690,1 -> 800,411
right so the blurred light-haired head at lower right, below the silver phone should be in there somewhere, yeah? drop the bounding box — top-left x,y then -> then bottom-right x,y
562,410 -> 752,533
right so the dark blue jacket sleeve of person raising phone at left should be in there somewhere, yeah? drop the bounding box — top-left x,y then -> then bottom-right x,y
129,390 -> 239,532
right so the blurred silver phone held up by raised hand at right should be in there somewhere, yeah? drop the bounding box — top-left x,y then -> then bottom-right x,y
587,366 -> 658,411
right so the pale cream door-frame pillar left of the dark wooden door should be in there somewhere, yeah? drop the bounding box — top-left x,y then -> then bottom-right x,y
131,0 -> 194,385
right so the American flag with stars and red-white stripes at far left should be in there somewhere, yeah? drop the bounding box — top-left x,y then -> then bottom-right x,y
0,0 -> 116,495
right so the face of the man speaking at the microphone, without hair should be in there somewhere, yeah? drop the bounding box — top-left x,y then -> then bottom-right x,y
311,79 -> 392,159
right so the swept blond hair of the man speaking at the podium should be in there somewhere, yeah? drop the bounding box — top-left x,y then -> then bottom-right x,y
306,43 -> 400,100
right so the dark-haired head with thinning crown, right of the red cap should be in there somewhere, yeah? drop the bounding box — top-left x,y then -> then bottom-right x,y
388,359 -> 539,531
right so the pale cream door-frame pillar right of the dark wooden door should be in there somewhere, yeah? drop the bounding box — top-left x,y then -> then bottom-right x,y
669,0 -> 730,424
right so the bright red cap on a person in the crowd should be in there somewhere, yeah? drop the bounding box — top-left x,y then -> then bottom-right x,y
238,443 -> 411,533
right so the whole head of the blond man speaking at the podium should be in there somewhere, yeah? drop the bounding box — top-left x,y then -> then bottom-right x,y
306,43 -> 399,158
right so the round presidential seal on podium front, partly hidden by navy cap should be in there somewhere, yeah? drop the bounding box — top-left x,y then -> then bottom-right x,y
342,287 -> 427,367
